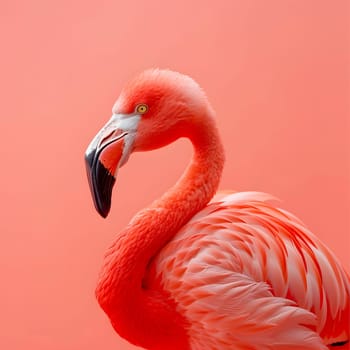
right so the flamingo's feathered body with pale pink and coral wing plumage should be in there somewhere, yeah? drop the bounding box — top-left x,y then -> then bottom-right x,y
147,192 -> 350,349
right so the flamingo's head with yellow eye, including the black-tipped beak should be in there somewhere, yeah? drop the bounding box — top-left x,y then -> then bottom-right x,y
85,69 -> 210,217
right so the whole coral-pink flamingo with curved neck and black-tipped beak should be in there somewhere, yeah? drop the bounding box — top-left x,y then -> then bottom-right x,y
85,69 -> 350,350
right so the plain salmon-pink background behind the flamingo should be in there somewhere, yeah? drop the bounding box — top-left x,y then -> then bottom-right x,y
0,0 -> 350,350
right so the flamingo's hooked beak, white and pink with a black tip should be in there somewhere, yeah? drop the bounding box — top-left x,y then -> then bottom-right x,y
85,114 -> 139,218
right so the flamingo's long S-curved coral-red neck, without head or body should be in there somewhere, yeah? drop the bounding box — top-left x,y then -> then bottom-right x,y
96,117 -> 224,349
